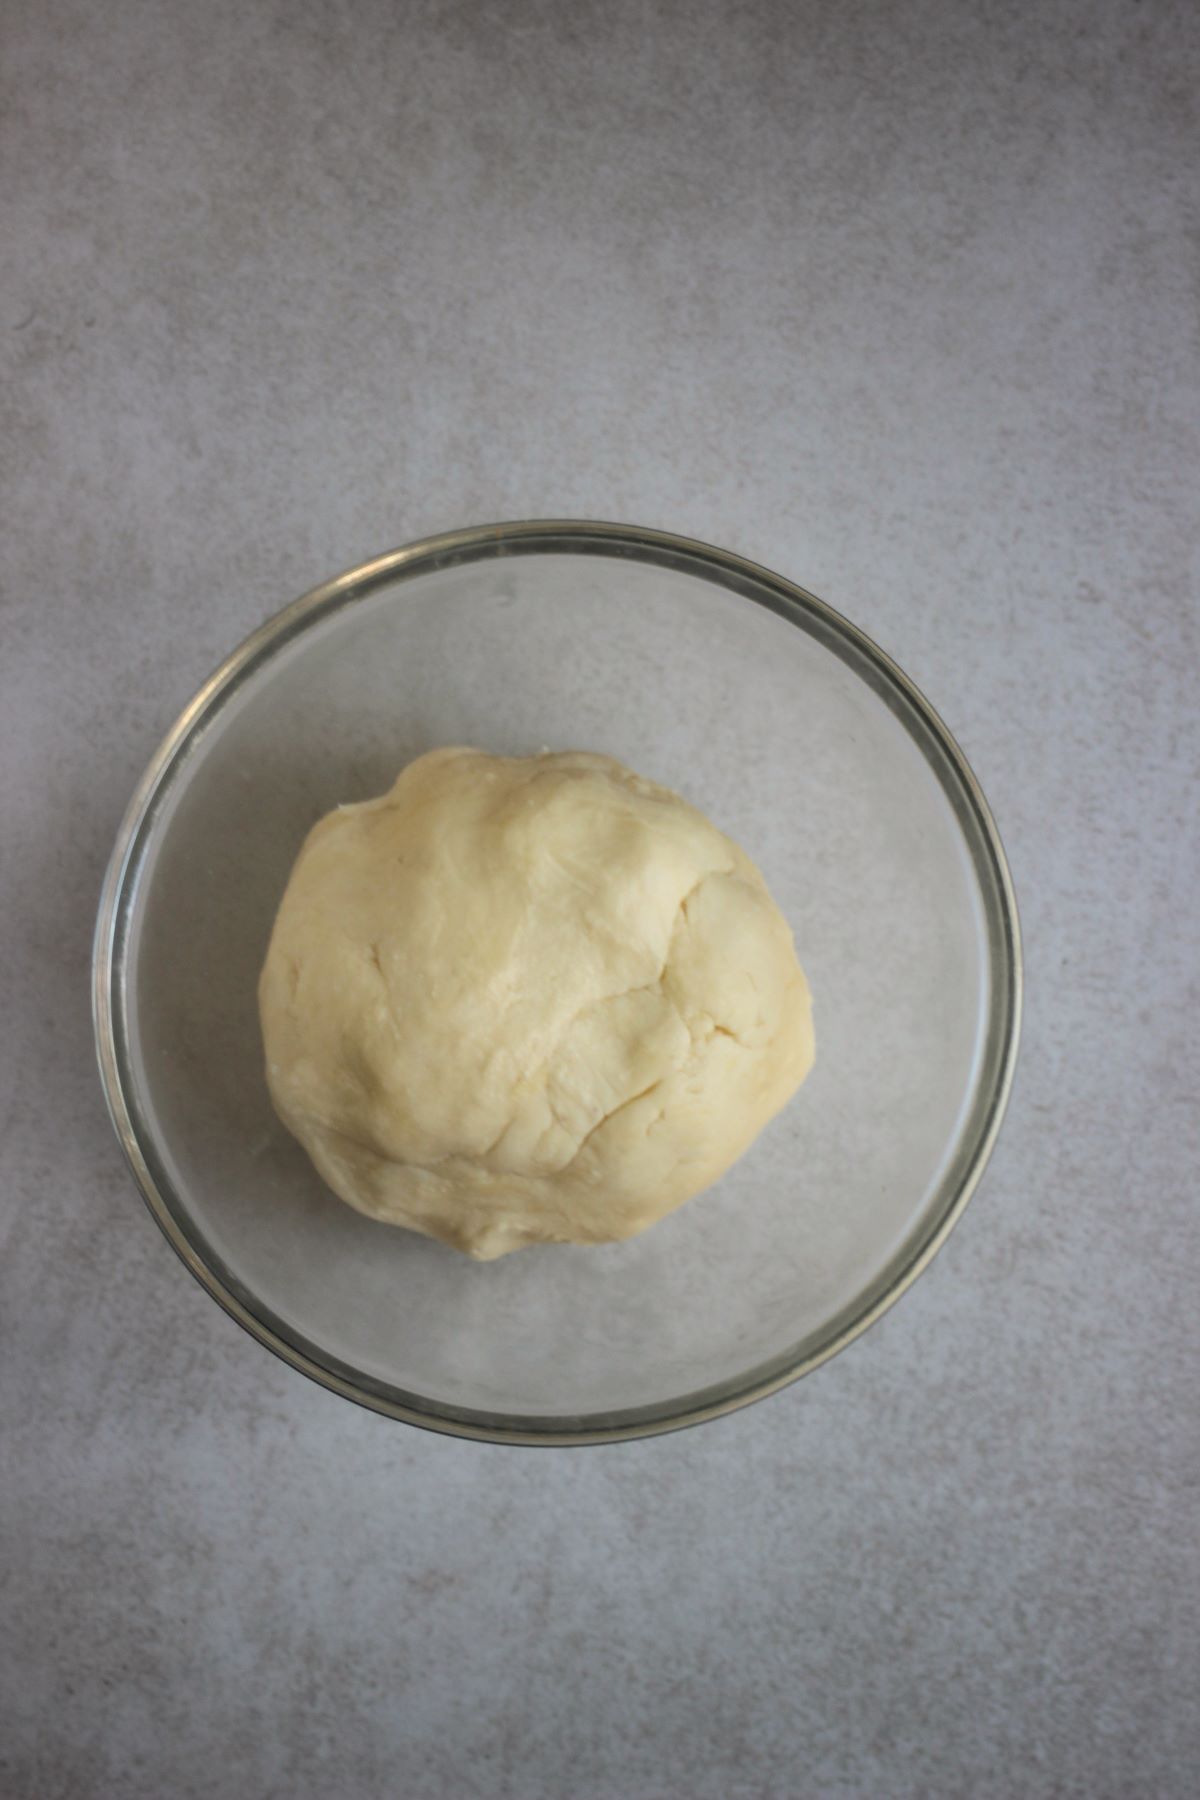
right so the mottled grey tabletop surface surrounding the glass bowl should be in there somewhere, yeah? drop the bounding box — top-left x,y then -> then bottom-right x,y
0,0 -> 1200,1800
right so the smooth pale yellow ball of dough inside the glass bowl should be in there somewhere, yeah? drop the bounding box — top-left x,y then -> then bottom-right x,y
259,749 -> 813,1258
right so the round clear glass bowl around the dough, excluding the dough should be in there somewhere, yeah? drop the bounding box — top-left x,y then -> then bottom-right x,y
94,522 -> 1020,1444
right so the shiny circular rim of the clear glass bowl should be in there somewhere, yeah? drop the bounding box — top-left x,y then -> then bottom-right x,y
92,518 -> 1024,1445
